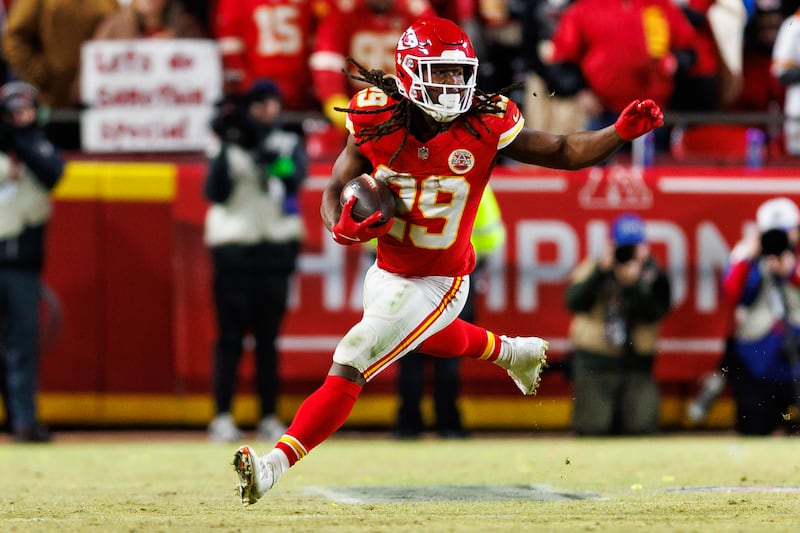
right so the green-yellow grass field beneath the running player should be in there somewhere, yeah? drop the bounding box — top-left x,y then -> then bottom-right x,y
0,433 -> 800,533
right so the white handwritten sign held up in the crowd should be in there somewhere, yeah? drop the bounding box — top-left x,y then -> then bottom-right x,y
81,39 -> 222,152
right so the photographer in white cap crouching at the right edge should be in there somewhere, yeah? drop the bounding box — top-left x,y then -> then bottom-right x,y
722,198 -> 800,435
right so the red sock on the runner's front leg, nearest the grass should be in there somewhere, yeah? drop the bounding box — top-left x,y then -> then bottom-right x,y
275,376 -> 361,466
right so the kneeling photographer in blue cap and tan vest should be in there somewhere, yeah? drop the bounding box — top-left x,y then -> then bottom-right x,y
566,214 -> 671,435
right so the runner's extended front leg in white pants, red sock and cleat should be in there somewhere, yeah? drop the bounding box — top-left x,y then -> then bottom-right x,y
234,265 -> 469,505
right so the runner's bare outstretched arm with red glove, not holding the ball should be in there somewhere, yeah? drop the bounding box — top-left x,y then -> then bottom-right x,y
500,100 -> 664,170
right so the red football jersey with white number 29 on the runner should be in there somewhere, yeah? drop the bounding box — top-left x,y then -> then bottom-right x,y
347,87 -> 525,276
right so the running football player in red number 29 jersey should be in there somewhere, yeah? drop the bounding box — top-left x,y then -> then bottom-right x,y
234,17 -> 664,505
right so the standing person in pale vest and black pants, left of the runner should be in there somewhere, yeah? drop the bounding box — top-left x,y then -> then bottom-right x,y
205,80 -> 308,442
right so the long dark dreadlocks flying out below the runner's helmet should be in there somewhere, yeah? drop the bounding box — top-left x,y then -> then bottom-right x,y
334,57 -> 522,166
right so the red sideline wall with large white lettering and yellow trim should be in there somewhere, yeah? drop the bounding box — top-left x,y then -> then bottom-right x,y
26,161 -> 800,428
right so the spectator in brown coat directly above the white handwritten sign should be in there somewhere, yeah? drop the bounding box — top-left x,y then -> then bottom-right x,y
93,0 -> 208,40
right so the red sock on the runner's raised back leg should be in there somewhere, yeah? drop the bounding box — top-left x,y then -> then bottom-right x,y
418,318 -> 500,361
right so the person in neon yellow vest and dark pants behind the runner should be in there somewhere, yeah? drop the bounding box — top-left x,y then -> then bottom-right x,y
395,186 -> 506,438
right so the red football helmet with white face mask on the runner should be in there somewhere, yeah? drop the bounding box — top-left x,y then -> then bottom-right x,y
395,17 -> 478,122
